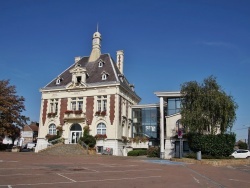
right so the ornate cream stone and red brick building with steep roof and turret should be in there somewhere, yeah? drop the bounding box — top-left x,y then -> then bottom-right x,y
36,31 -> 141,155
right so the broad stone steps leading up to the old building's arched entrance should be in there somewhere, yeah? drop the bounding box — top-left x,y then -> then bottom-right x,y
39,143 -> 87,155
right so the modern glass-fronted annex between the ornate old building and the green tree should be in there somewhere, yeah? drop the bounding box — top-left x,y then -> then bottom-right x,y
132,92 -> 189,158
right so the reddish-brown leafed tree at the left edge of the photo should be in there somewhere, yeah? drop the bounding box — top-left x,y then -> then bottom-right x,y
0,80 -> 29,139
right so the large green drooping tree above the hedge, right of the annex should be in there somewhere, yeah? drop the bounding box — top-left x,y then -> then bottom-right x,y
181,76 -> 238,134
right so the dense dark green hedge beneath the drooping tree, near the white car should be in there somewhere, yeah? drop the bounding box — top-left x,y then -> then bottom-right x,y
187,133 -> 235,158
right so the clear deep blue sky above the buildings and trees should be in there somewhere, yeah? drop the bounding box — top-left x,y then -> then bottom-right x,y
0,0 -> 250,139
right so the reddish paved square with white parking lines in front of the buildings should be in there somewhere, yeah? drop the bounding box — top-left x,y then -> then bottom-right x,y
0,152 -> 250,188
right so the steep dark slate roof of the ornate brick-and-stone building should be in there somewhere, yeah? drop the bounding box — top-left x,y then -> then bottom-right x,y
42,54 -> 139,98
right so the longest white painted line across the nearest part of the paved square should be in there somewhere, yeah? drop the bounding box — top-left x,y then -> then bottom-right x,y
0,174 -> 162,187
